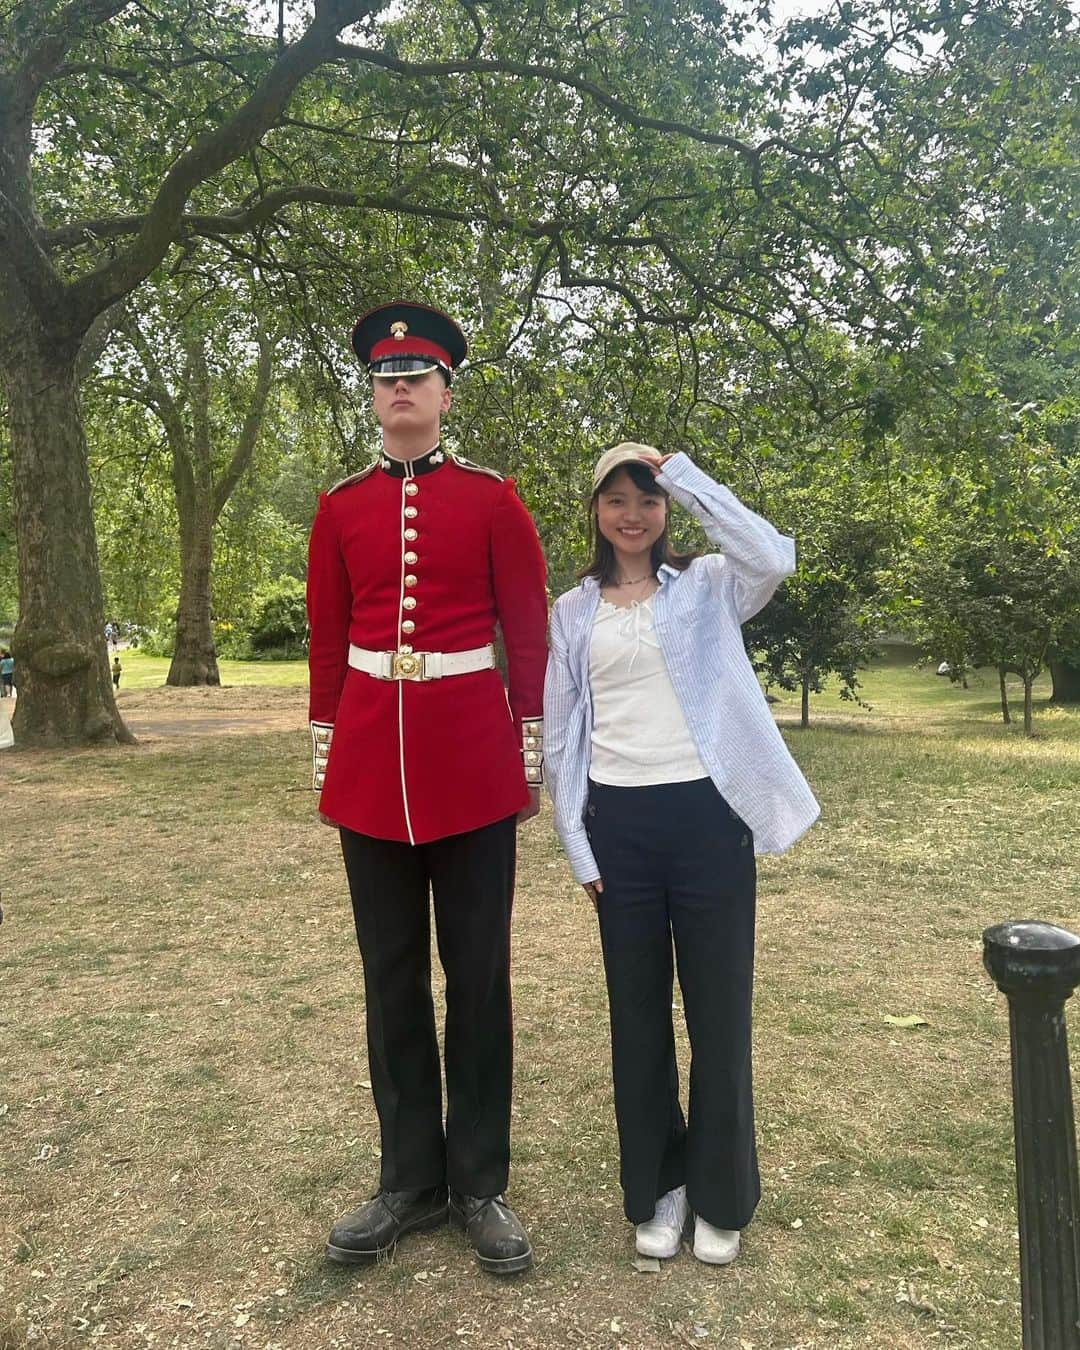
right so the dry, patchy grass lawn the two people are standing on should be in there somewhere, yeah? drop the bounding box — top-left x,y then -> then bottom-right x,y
0,653 -> 1080,1350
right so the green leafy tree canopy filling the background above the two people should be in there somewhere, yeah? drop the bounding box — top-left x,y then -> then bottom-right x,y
0,0 -> 1080,739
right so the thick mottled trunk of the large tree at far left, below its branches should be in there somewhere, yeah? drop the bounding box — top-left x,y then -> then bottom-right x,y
3,333 -> 135,747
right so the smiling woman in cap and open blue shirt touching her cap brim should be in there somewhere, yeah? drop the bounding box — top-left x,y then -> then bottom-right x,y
544,443 -> 818,1265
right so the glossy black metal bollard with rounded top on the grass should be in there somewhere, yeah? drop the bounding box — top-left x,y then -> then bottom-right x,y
983,919 -> 1080,1350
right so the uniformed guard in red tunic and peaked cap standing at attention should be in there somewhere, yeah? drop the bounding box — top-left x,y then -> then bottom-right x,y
308,304 -> 547,1274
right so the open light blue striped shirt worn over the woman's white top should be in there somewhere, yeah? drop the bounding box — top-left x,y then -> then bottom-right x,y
544,454 -> 819,882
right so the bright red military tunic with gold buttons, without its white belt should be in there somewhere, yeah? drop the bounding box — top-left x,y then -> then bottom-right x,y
308,448 -> 547,844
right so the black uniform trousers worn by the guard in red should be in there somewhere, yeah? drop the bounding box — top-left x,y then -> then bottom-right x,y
342,815 -> 517,1195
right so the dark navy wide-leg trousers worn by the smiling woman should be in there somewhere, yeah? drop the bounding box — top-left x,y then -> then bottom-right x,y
585,779 -> 761,1229
